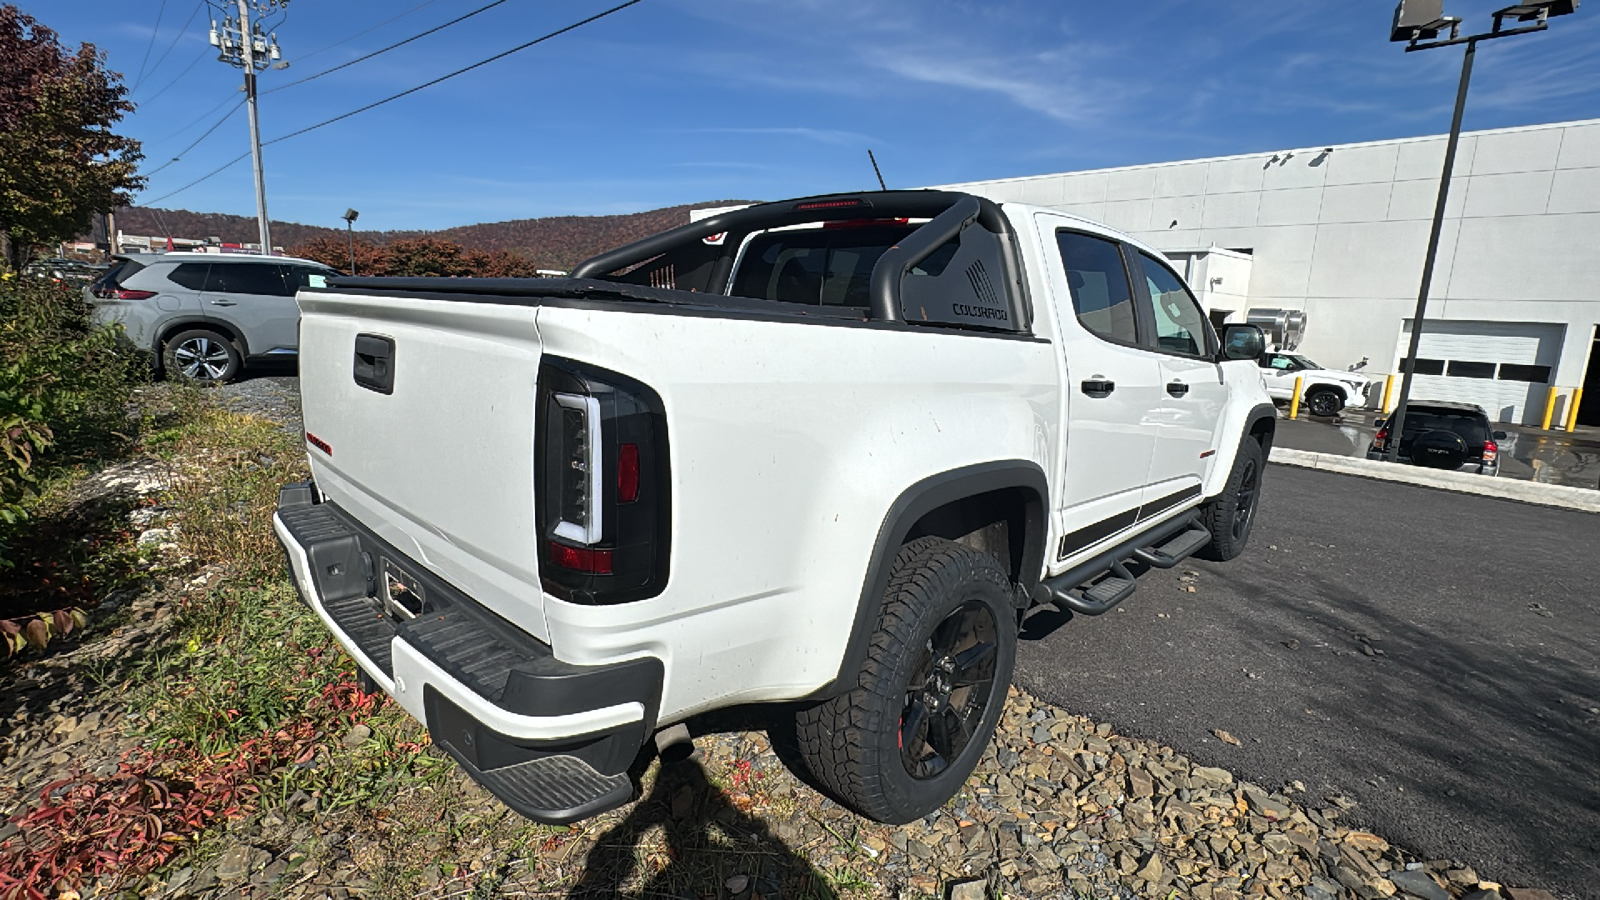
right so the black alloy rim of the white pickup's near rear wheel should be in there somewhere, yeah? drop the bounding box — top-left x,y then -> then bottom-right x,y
899,601 -> 998,780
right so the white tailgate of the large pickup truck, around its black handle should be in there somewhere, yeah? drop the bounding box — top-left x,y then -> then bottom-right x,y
299,291 -> 547,641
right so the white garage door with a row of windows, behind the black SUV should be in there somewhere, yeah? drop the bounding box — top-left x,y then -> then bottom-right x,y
1395,319 -> 1566,423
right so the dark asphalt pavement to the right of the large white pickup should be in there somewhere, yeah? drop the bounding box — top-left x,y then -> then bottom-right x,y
1018,466 -> 1600,897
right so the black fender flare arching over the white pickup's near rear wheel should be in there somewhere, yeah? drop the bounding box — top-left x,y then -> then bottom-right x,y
808,460 -> 1050,700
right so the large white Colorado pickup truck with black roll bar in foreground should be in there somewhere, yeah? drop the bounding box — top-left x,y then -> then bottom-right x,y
274,191 -> 1275,823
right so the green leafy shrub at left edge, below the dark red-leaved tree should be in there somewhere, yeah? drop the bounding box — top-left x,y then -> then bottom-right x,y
0,274 -> 142,565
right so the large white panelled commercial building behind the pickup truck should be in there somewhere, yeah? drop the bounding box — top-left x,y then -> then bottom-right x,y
946,120 -> 1600,424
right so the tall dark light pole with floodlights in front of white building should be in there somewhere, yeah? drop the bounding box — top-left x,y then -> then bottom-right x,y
1384,0 -> 1579,463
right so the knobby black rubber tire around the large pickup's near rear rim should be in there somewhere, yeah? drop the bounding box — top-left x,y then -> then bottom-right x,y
795,538 -> 1016,825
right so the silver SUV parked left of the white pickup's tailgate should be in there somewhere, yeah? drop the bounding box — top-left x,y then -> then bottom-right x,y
83,253 -> 338,381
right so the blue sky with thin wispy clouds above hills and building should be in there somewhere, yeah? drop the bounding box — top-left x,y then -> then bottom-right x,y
43,0 -> 1600,229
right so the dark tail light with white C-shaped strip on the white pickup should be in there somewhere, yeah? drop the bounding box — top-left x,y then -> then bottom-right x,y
534,357 -> 670,604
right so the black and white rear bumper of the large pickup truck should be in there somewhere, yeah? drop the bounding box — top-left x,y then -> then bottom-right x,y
272,482 -> 664,825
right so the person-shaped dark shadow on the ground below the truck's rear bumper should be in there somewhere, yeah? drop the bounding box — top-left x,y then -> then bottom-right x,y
566,746 -> 838,900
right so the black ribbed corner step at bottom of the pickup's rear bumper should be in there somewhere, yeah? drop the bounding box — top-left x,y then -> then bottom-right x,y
464,748 -> 634,825
